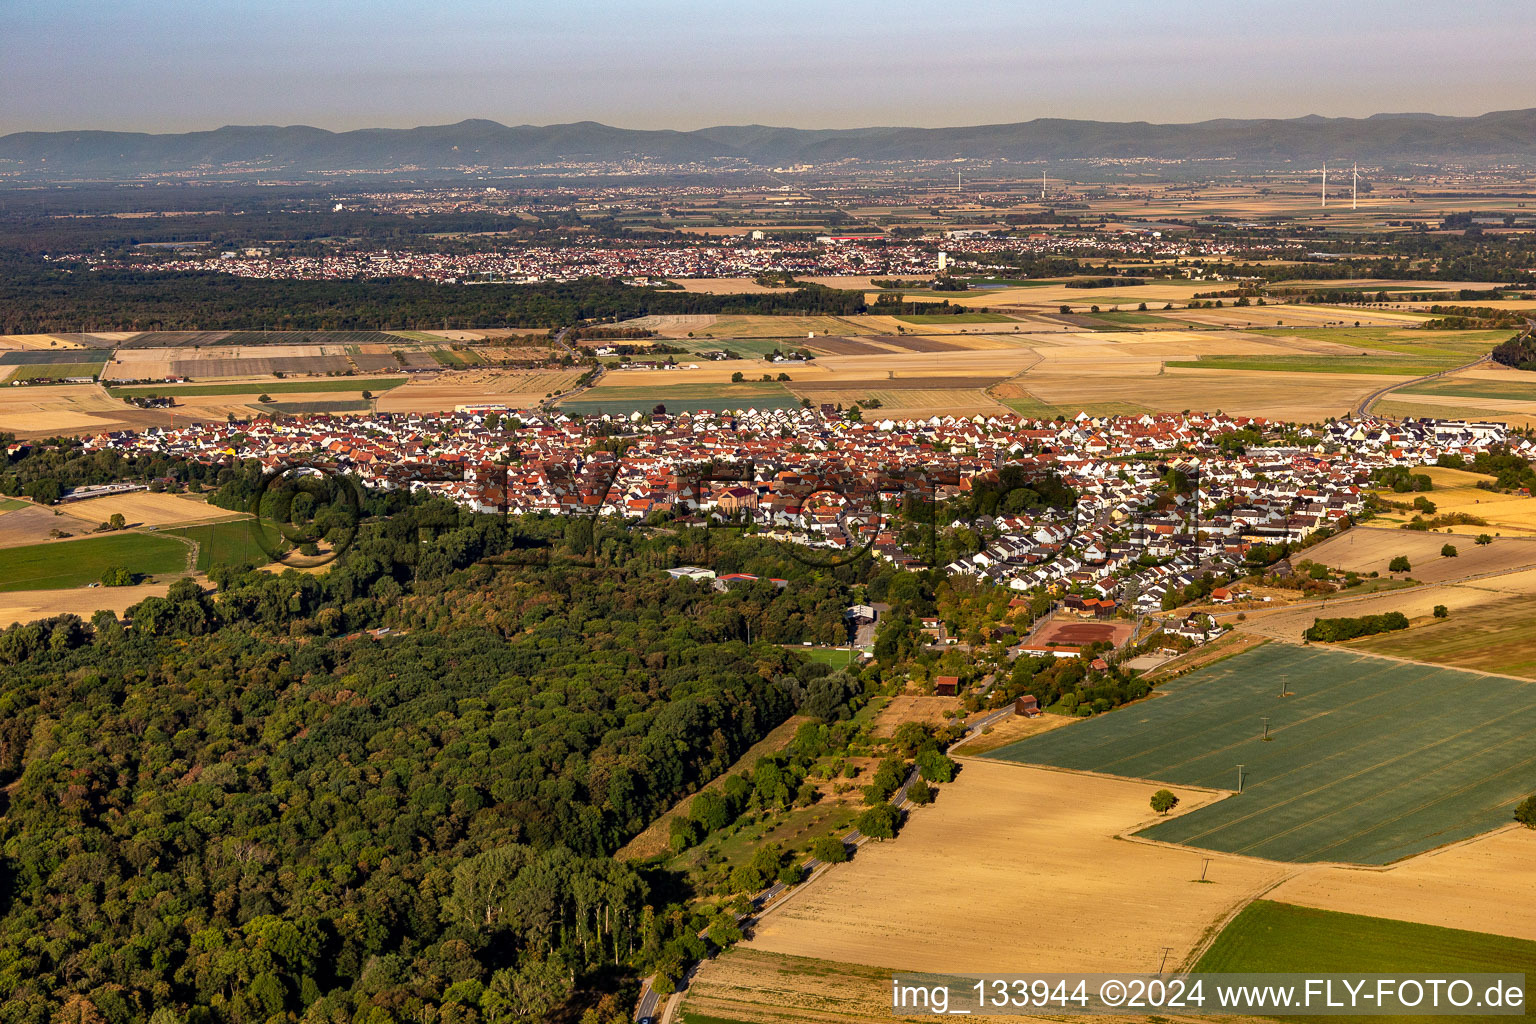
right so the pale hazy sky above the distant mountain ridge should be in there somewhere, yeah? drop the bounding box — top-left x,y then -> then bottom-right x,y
0,0 -> 1536,134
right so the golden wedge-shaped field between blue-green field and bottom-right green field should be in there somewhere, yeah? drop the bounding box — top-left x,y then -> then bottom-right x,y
1264,824 -> 1536,940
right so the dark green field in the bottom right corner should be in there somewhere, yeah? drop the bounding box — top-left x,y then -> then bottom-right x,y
1195,900 -> 1536,1022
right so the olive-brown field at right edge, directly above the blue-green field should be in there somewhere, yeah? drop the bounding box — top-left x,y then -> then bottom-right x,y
1346,594 -> 1536,679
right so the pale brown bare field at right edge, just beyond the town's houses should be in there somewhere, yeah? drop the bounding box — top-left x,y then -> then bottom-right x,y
1306,525 -> 1536,583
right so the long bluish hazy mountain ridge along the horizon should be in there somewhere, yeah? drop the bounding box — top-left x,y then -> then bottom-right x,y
0,109 -> 1536,178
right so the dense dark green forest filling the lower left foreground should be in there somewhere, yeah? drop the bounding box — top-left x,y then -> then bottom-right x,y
0,482 -> 889,1024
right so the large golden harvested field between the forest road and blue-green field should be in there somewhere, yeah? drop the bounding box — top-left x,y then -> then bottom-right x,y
745,764 -> 1287,984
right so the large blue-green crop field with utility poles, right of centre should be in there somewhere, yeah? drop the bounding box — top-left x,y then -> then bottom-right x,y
989,643 -> 1536,864
